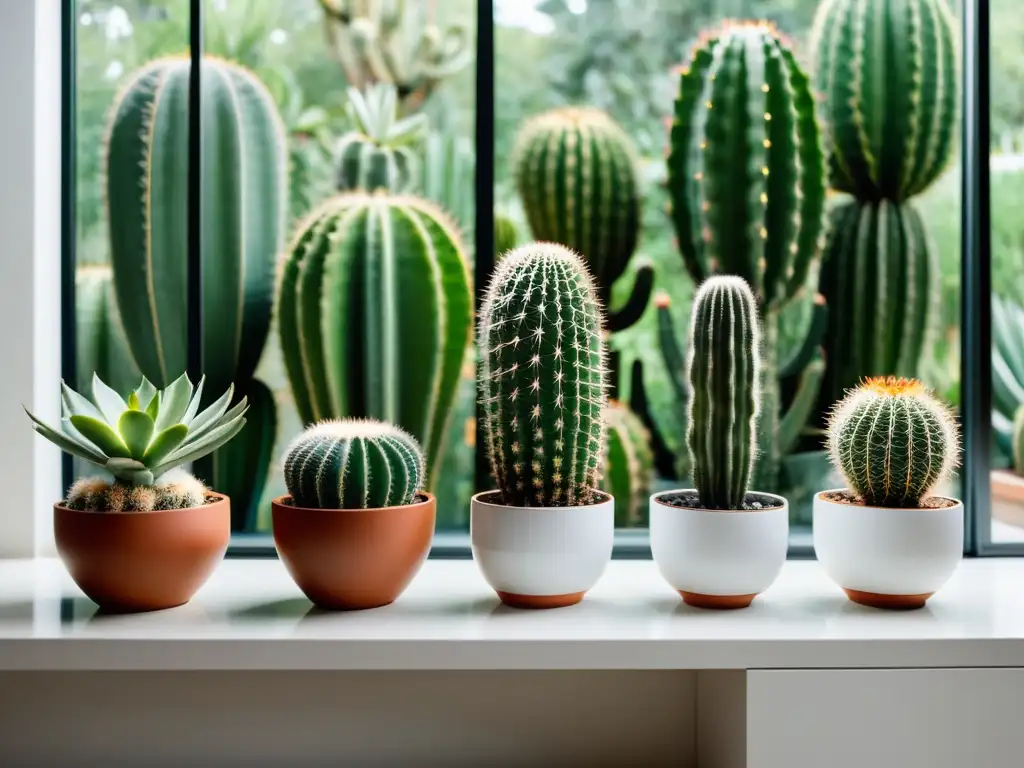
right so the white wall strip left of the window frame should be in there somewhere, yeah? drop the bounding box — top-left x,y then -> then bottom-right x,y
0,0 -> 61,557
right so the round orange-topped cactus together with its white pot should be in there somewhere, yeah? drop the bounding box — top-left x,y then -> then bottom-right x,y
814,377 -> 964,609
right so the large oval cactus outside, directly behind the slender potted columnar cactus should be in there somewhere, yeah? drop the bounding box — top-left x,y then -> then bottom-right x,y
668,24 -> 825,312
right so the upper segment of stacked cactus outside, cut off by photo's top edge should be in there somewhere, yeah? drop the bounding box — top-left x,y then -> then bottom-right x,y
811,0 -> 959,202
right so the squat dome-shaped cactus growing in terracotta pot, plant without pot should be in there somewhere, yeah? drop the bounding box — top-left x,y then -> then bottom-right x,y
285,419 -> 426,509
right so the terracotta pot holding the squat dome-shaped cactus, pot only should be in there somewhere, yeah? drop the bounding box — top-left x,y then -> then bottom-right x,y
271,492 -> 436,610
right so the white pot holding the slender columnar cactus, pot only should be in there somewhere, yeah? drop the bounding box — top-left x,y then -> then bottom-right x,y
650,490 -> 790,608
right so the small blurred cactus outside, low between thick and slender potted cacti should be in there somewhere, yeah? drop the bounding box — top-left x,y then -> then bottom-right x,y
601,400 -> 654,527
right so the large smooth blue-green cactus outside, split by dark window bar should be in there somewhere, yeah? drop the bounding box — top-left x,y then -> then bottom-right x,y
105,57 -> 288,391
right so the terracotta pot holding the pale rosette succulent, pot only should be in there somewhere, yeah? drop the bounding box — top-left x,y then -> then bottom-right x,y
53,493 -> 231,612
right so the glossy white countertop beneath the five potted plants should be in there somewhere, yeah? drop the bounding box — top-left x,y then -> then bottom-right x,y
0,558 -> 1024,670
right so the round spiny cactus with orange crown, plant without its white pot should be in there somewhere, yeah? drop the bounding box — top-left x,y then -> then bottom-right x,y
828,376 -> 959,507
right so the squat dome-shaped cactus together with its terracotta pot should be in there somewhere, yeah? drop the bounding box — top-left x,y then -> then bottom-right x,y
271,419 -> 436,610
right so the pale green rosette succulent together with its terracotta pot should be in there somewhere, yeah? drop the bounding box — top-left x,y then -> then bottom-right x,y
26,375 -> 248,611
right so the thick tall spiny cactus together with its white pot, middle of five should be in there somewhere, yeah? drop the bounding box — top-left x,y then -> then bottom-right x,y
470,243 -> 614,608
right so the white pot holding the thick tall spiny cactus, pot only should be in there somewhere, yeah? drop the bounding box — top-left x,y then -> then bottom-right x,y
469,492 -> 615,608
